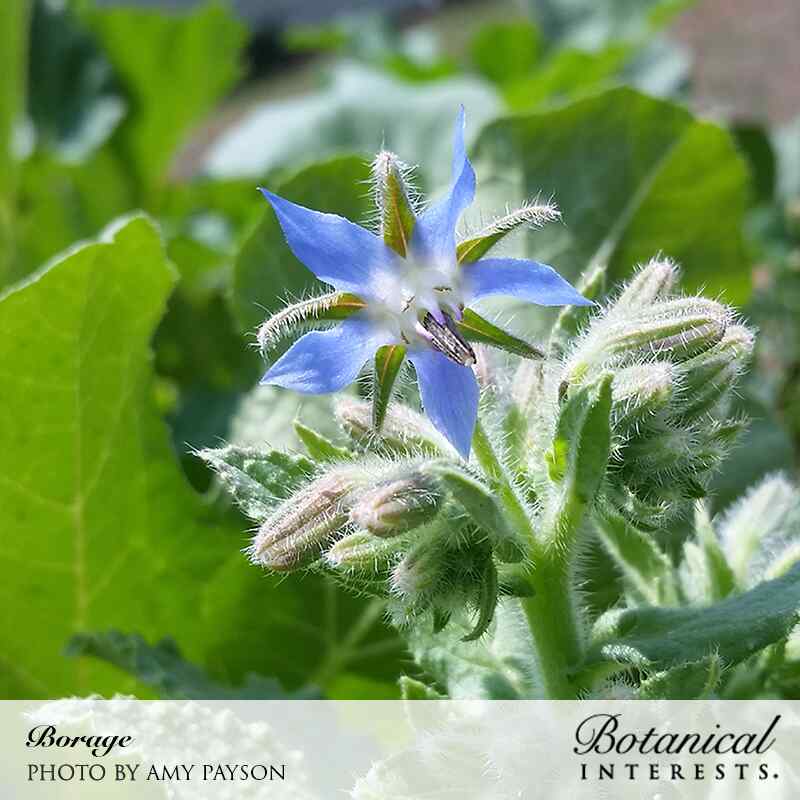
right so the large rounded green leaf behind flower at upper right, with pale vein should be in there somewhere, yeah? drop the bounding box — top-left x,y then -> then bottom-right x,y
477,88 -> 749,303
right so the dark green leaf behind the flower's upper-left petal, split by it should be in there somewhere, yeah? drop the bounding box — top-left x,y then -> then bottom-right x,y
231,156 -> 371,330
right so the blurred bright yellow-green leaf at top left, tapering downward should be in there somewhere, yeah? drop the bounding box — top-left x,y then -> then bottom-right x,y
86,2 -> 246,192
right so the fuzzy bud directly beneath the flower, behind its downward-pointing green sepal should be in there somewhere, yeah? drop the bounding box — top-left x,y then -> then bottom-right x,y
333,397 -> 449,455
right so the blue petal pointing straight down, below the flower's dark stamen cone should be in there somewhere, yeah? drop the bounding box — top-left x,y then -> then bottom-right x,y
408,350 -> 478,458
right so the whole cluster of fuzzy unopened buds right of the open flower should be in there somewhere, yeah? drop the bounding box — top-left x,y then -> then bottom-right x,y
557,260 -> 754,524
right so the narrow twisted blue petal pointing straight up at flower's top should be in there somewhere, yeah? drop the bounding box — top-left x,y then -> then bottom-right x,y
412,106 -> 475,263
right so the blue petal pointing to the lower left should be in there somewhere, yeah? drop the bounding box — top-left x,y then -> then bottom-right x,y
261,314 -> 392,394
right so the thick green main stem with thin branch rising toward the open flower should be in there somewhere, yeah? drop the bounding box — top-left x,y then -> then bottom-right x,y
472,421 -> 583,699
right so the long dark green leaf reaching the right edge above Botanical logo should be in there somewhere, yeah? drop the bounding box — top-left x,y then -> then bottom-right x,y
587,565 -> 800,670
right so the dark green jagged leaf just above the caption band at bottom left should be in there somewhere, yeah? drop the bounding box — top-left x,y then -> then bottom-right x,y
66,630 -> 310,700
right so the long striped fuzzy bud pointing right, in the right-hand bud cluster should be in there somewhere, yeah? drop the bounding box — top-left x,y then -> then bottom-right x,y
567,297 -> 730,383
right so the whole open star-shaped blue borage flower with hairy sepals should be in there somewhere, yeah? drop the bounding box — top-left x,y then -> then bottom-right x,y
261,108 -> 591,458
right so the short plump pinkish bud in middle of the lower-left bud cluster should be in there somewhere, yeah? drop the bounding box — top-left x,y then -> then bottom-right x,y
350,470 -> 442,537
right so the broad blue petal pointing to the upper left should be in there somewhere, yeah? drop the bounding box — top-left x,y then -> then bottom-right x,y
261,189 -> 398,297
